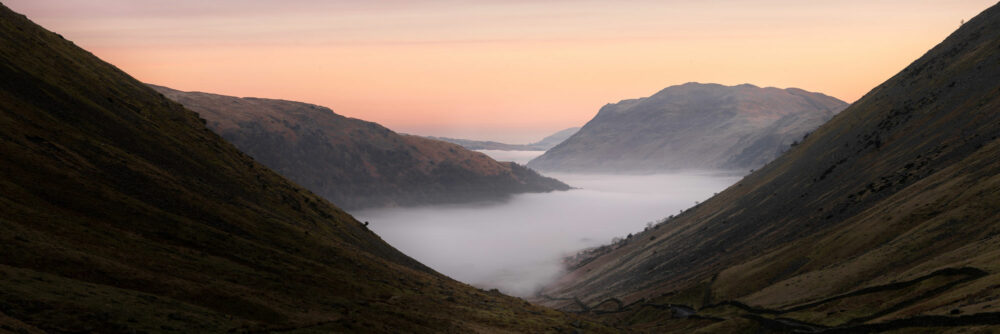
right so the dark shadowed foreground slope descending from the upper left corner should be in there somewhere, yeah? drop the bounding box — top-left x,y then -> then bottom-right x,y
0,6 -> 608,333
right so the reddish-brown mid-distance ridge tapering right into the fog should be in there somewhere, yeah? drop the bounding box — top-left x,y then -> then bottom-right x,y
152,86 -> 569,209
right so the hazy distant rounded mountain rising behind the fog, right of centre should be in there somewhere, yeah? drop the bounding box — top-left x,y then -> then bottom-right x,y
528,83 -> 847,172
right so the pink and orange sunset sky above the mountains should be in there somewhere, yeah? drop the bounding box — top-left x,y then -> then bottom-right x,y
3,0 -> 995,143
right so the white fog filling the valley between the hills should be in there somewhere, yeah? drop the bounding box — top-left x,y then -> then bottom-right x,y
352,151 -> 741,296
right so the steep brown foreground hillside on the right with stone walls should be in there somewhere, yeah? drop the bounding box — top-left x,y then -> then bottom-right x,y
540,5 -> 1000,333
